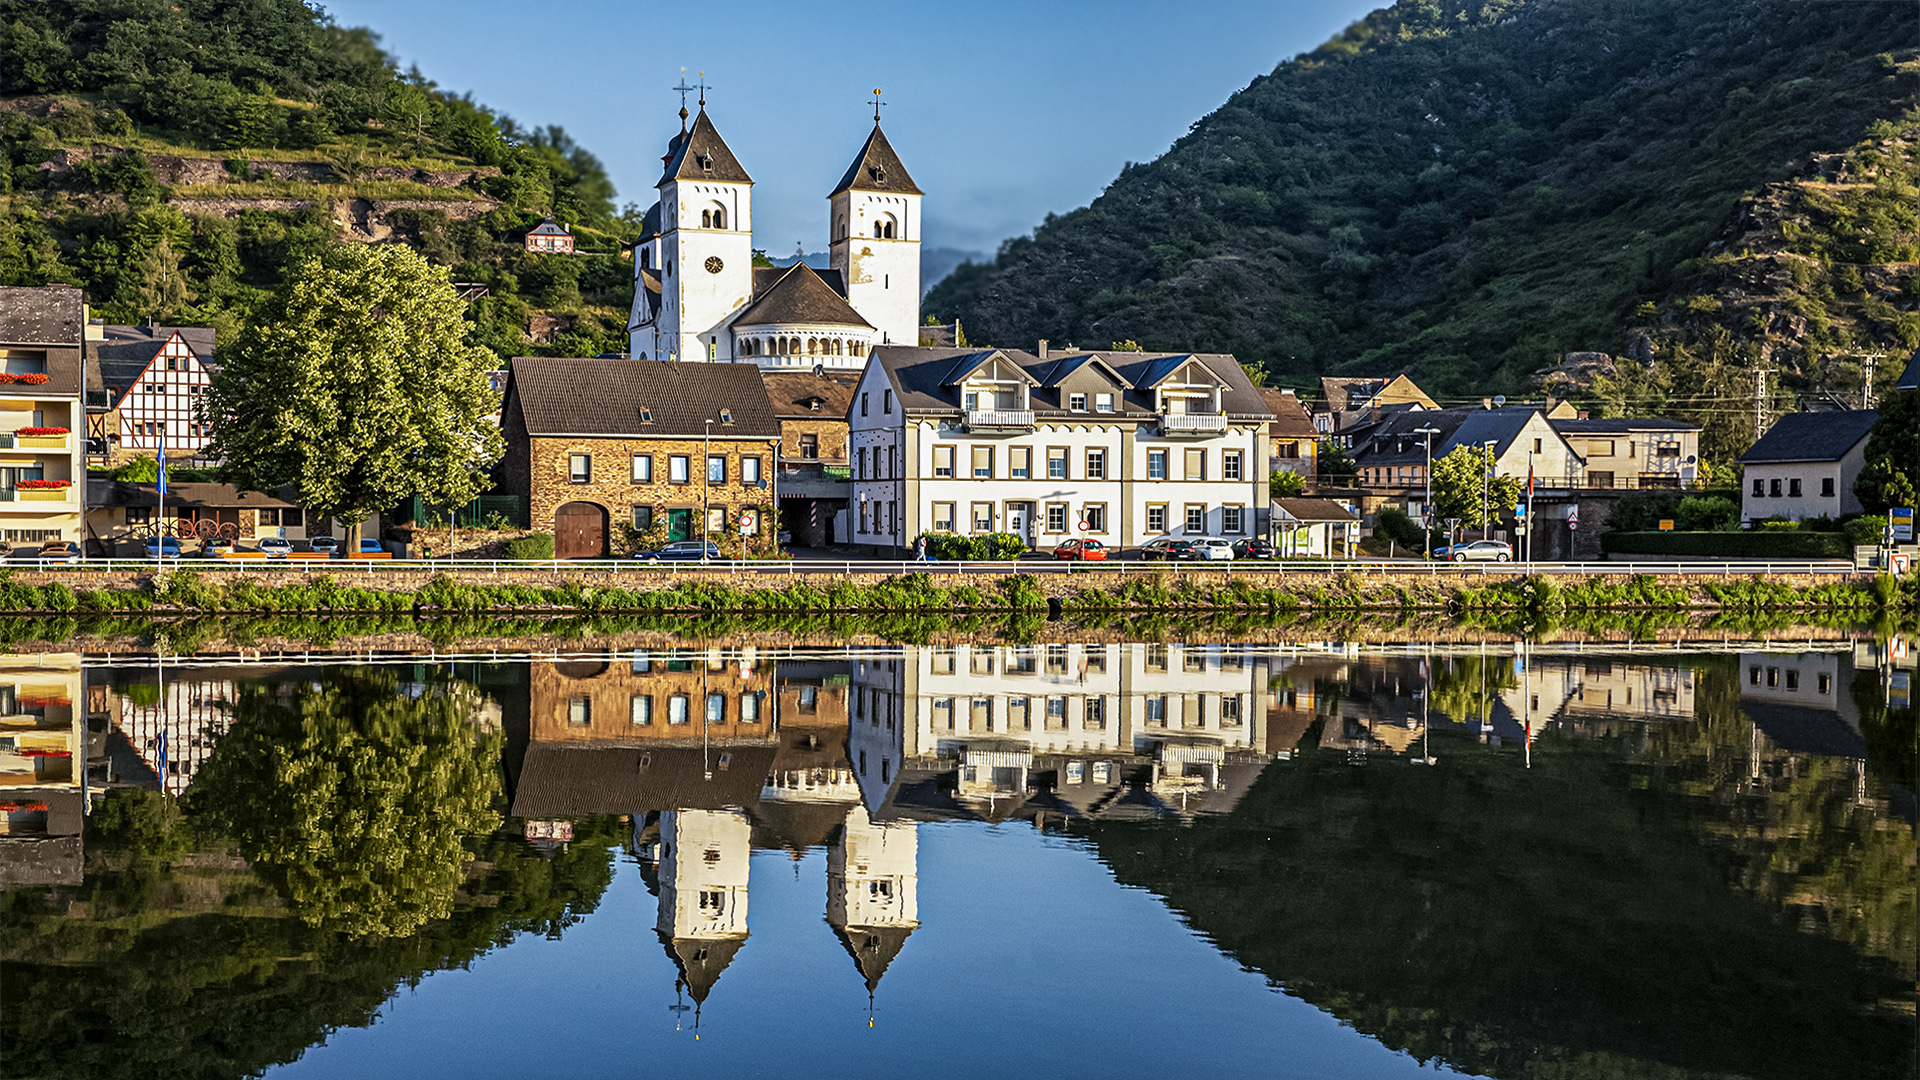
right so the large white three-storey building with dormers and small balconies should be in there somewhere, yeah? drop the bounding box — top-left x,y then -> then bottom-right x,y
847,346 -> 1273,552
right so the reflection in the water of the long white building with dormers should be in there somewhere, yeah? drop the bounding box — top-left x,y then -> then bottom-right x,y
847,644 -> 1271,819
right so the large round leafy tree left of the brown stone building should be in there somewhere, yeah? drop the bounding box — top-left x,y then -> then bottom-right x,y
205,244 -> 501,525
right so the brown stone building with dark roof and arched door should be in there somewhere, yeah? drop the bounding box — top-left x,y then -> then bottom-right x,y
499,357 -> 780,559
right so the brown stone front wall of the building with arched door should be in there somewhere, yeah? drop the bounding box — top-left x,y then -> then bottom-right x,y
526,430 -> 774,552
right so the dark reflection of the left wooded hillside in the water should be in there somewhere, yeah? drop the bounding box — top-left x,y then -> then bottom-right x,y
0,790 -> 624,1080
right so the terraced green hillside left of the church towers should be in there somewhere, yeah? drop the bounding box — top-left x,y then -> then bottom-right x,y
0,0 -> 637,356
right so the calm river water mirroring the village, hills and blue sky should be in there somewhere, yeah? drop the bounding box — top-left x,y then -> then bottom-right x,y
0,638 -> 1916,1080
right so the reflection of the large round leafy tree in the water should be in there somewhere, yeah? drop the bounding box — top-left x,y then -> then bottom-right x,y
190,671 -> 499,936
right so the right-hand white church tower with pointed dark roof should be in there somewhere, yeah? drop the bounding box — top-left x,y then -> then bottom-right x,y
828,110 -> 922,346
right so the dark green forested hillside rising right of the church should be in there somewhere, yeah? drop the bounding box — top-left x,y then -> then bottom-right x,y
927,0 -> 1920,411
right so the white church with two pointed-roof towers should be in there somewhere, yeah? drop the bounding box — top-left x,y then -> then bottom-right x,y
628,96 -> 922,371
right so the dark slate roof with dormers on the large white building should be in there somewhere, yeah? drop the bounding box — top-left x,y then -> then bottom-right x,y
872,346 -> 1273,421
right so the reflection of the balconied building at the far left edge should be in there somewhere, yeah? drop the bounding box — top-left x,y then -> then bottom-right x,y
0,653 -> 86,888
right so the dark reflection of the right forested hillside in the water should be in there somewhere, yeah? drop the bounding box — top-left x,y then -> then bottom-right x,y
1073,663 -> 1914,1080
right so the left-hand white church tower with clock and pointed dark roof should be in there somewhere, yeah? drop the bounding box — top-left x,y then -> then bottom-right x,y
652,96 -> 753,361
